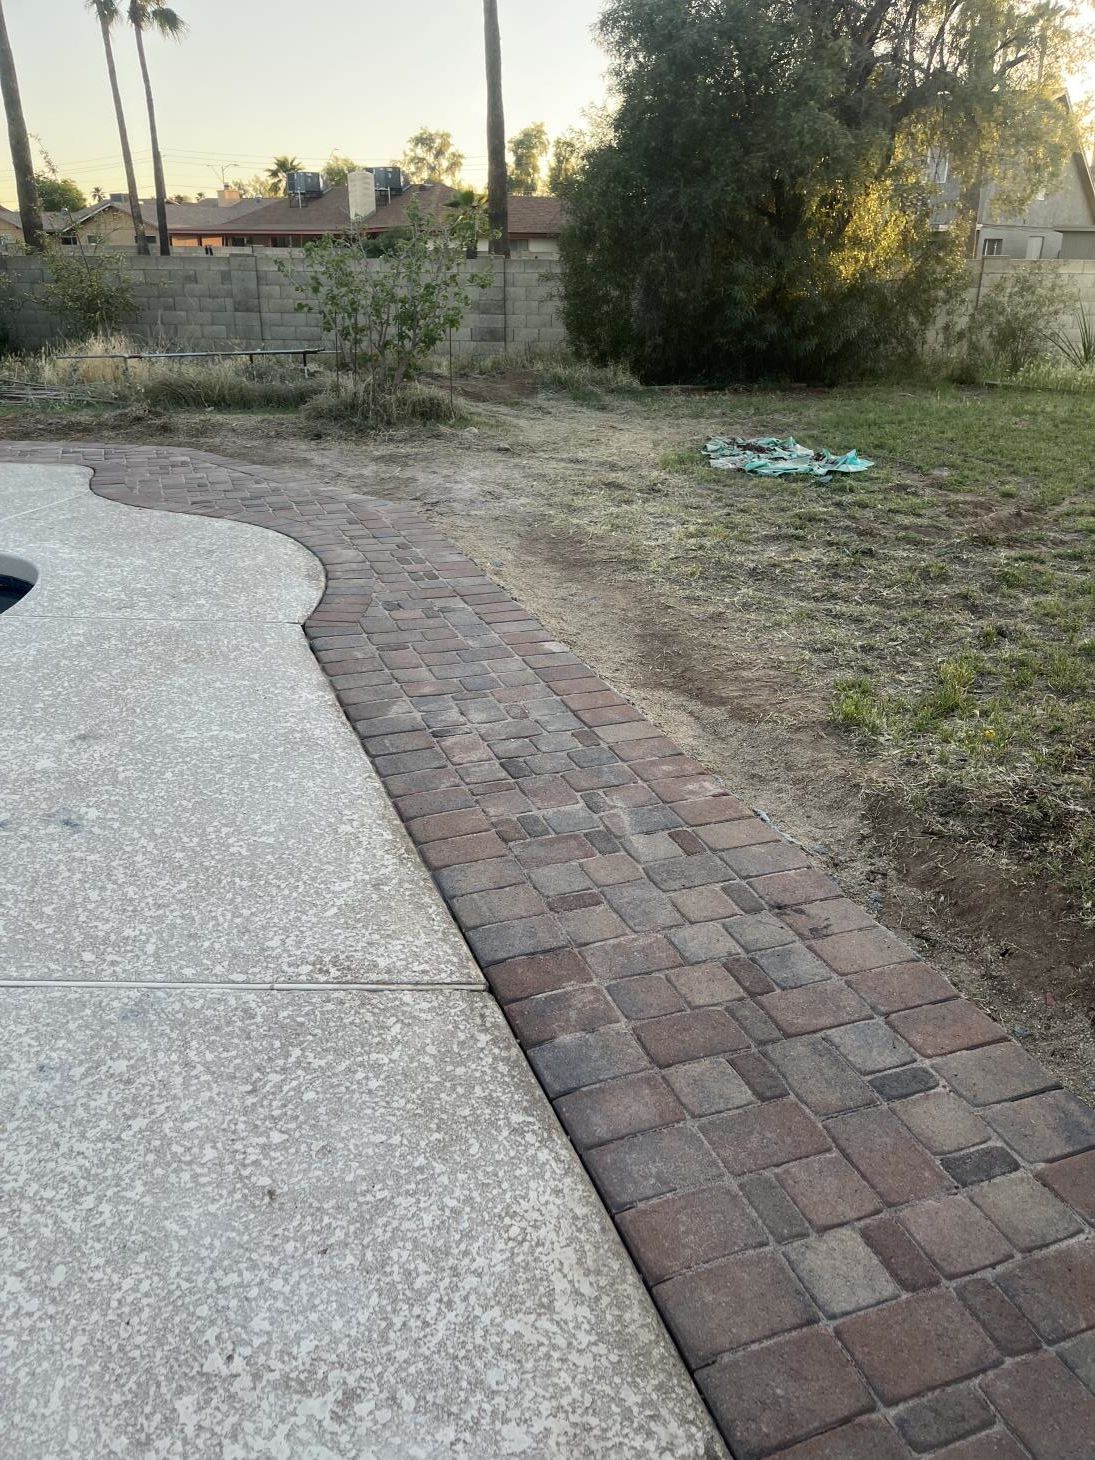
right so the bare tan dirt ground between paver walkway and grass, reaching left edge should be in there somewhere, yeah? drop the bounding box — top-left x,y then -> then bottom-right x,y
0,388 -> 1095,1098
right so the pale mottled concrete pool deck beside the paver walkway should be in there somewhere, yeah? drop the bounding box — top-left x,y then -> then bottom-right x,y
0,464 -> 724,1460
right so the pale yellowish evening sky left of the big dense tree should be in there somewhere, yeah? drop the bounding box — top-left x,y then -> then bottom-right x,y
0,0 -> 604,207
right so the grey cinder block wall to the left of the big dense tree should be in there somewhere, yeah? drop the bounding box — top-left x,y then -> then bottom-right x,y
0,250 -> 566,353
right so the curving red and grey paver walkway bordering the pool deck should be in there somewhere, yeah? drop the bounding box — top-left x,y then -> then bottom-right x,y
3,445 -> 1095,1460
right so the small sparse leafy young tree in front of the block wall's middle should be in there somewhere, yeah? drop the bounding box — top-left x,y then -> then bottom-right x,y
279,204 -> 491,423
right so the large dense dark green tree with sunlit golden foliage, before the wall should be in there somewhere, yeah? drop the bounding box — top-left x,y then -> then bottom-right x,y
562,0 -> 1077,380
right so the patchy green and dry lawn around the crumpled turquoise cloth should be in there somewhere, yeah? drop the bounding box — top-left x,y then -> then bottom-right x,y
561,385 -> 1095,920
